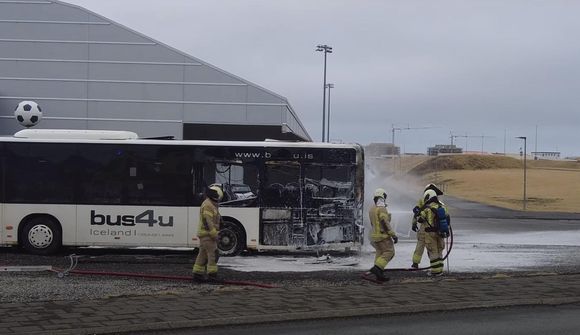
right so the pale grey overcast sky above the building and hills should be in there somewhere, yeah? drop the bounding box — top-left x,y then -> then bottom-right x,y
68,0 -> 580,155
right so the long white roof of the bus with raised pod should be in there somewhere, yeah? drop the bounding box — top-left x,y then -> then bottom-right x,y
0,129 -> 360,149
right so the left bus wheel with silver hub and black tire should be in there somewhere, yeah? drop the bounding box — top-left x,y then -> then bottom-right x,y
21,215 -> 62,255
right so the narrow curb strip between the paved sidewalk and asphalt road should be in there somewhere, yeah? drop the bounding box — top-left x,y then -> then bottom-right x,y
30,297 -> 580,335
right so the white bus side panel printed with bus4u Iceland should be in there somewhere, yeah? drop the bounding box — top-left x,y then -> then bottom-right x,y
77,205 -> 188,247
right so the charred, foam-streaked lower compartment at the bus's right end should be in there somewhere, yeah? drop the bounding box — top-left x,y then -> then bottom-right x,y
260,178 -> 359,249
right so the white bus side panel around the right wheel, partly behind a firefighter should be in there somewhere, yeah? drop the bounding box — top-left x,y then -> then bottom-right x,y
189,207 -> 260,250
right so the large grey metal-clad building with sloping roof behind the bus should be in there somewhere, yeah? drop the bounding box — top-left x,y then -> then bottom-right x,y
0,0 -> 311,141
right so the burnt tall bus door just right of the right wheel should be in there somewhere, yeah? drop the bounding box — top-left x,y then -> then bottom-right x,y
260,161 -> 308,249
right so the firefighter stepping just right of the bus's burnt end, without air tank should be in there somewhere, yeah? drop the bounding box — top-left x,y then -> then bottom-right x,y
369,188 -> 398,281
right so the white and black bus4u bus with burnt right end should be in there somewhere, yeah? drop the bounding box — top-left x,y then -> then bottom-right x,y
0,129 -> 364,255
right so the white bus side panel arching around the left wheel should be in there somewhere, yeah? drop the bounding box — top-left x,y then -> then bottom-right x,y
3,204 -> 76,245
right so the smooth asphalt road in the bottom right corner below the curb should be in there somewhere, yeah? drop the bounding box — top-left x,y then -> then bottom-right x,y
138,305 -> 580,335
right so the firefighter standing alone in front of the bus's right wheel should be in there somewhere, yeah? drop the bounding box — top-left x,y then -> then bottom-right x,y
193,185 -> 223,281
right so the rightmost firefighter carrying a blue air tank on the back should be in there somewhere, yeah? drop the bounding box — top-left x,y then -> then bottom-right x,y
417,189 -> 447,276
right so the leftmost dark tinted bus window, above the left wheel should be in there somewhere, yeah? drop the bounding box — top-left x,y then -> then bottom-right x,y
5,143 -> 77,204
